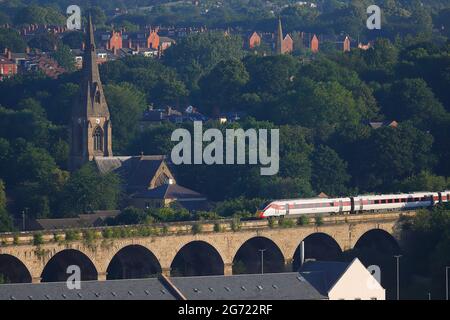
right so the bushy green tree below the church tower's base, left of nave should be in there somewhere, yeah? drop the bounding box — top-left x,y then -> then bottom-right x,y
61,163 -> 121,216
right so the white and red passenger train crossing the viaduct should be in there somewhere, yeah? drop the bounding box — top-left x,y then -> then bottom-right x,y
257,191 -> 450,219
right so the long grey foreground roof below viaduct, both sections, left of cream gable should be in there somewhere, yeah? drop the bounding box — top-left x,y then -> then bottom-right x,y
0,272 -> 327,300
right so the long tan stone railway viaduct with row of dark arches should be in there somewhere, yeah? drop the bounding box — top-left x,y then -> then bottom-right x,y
0,212 -> 415,283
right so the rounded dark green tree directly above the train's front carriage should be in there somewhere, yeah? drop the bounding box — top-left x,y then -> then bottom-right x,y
311,145 -> 350,196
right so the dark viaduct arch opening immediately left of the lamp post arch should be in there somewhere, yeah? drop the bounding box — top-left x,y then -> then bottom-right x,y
170,240 -> 224,276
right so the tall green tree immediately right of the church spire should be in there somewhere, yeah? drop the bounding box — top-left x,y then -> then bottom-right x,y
105,83 -> 146,153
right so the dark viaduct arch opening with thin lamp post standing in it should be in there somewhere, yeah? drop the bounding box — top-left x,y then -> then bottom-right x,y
233,236 -> 285,274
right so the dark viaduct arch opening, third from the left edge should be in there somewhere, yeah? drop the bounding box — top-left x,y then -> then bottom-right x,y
106,244 -> 162,280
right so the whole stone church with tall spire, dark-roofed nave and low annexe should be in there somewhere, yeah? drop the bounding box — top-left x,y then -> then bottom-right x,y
69,17 -> 207,210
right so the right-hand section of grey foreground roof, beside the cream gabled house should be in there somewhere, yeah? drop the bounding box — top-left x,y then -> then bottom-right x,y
171,272 -> 327,300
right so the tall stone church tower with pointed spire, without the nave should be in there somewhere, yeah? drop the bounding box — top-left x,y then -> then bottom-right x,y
69,16 -> 113,171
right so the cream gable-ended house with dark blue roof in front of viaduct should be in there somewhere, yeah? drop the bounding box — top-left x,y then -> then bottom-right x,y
300,258 -> 386,300
